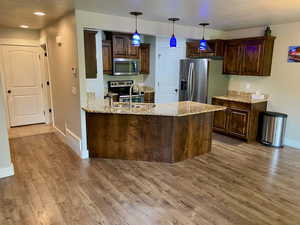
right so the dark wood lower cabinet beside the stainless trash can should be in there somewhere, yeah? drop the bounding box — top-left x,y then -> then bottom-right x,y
212,98 -> 267,141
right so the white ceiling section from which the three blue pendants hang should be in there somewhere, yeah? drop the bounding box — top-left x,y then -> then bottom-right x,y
75,0 -> 300,30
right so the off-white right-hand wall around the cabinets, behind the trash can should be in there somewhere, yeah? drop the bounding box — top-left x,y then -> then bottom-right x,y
226,22 -> 300,148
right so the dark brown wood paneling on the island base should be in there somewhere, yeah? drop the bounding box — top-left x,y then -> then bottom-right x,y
87,112 -> 213,163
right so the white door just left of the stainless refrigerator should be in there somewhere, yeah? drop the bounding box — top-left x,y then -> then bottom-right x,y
155,38 -> 185,103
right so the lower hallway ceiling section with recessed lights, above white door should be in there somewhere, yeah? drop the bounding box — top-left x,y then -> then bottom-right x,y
0,0 -> 74,29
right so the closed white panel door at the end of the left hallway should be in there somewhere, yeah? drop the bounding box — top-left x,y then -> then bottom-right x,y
3,46 -> 45,126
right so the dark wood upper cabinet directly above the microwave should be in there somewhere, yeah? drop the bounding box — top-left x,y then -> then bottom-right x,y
112,34 -> 139,59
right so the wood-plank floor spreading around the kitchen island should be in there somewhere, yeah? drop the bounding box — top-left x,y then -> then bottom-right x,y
0,134 -> 300,225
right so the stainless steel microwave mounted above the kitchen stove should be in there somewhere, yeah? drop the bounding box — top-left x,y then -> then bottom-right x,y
113,58 -> 140,76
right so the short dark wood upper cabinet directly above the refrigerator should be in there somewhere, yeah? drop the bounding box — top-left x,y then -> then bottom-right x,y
186,39 -> 224,58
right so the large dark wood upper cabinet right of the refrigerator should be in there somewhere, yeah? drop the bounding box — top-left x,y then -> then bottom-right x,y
223,37 -> 275,76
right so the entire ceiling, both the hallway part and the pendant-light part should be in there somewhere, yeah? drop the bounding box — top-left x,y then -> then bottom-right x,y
0,0 -> 300,30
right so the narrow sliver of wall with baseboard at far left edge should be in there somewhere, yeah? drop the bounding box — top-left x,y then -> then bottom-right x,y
0,79 -> 14,178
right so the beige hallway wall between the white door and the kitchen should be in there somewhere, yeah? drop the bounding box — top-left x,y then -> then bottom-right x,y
41,13 -> 86,157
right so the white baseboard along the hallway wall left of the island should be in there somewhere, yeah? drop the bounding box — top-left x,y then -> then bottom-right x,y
54,125 -> 89,159
